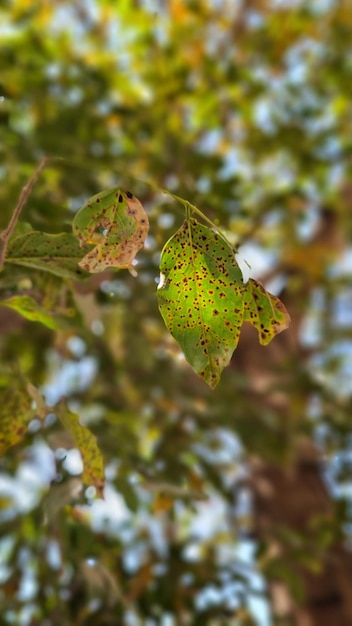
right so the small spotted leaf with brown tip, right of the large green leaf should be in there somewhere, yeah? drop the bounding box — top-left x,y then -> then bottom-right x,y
243,278 -> 291,346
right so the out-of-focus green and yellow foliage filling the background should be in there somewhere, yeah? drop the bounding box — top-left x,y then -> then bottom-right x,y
0,0 -> 352,626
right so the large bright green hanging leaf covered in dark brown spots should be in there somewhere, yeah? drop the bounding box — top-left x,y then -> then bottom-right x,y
158,219 -> 243,388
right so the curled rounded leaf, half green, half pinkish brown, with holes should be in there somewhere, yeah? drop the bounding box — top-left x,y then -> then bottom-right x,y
72,187 -> 149,273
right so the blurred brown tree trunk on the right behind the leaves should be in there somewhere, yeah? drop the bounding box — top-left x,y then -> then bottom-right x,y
232,211 -> 352,626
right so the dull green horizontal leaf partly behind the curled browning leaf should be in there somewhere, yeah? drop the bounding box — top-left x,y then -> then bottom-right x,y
6,231 -> 88,279
